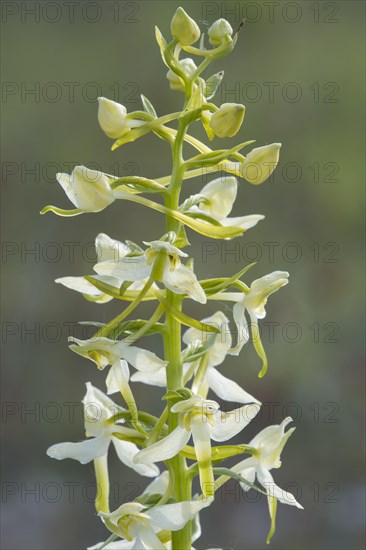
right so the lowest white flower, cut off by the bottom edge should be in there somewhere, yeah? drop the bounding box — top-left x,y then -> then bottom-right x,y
99,499 -> 212,550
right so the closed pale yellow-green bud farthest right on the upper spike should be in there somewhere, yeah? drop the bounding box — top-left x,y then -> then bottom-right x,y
241,143 -> 281,185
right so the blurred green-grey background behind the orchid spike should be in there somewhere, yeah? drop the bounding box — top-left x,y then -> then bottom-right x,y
1,0 -> 364,550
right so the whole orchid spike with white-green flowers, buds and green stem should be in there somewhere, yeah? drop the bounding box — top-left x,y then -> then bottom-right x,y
42,8 -> 301,550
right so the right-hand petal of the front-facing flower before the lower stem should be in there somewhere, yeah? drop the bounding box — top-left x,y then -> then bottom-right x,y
211,403 -> 260,441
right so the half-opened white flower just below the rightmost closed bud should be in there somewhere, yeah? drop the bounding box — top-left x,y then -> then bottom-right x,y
188,176 -> 264,230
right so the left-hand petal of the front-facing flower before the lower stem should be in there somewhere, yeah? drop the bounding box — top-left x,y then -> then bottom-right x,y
134,426 -> 191,464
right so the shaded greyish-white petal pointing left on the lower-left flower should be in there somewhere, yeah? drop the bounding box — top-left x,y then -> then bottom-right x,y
47,436 -> 110,464
